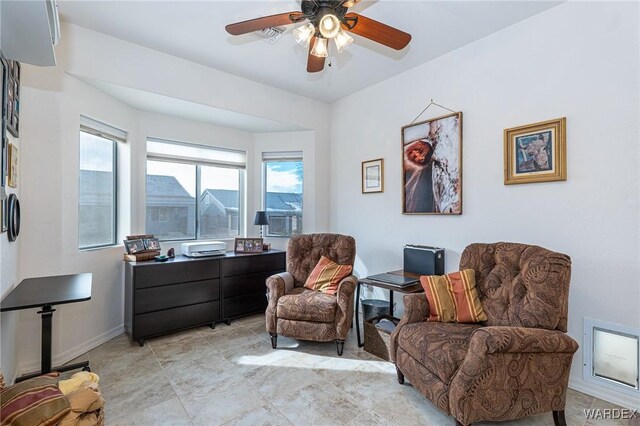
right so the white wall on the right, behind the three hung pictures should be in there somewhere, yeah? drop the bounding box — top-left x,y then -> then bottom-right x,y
330,2 -> 640,412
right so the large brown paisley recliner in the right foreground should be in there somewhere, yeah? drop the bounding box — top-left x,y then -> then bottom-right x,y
390,243 -> 578,425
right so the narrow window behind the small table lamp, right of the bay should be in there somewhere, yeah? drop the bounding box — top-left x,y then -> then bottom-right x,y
262,151 -> 304,237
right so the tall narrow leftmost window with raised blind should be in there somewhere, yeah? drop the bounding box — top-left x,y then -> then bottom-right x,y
78,116 -> 127,249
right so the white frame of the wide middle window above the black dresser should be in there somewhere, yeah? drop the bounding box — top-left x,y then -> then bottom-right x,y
144,137 -> 246,242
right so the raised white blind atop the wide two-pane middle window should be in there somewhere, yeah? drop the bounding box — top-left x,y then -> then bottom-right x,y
147,138 -> 247,169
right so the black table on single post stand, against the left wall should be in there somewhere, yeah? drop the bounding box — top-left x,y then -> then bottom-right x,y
0,273 -> 92,382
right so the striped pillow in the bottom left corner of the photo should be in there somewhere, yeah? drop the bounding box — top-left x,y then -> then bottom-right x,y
0,373 -> 71,426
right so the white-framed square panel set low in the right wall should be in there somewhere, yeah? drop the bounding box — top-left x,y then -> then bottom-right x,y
582,318 -> 640,397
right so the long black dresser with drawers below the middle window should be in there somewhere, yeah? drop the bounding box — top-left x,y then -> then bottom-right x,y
124,250 -> 285,346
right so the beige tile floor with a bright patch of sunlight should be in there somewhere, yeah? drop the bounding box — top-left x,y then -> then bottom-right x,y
74,315 -> 640,426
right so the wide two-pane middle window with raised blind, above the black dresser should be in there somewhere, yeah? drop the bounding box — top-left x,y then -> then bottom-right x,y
146,139 -> 246,241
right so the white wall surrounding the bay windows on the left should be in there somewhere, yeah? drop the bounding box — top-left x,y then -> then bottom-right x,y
5,20 -> 329,380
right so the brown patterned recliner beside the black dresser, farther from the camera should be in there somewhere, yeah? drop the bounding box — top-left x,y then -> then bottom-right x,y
266,234 -> 357,355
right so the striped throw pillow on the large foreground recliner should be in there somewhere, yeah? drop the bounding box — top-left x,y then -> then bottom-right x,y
420,269 -> 487,323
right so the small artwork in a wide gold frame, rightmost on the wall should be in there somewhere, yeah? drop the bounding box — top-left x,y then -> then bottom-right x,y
504,117 -> 567,185
